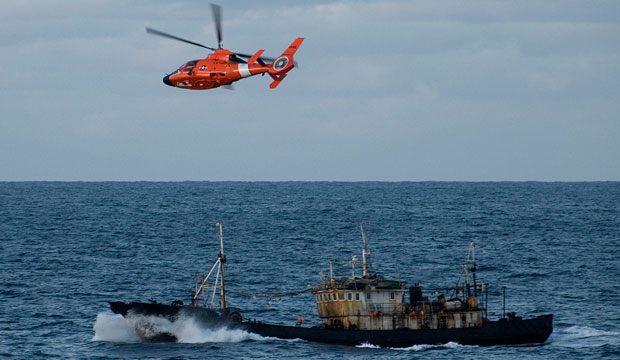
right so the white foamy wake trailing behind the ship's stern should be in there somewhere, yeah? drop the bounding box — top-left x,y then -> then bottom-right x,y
550,326 -> 620,347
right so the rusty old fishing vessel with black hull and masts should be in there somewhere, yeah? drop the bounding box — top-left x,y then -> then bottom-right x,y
110,223 -> 553,347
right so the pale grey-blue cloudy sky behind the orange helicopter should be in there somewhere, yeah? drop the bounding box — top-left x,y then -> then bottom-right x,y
0,0 -> 620,181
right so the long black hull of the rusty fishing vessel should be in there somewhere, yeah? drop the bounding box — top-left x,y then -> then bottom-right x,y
110,302 -> 553,347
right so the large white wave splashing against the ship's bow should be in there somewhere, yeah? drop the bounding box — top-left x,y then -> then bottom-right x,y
92,312 -> 270,343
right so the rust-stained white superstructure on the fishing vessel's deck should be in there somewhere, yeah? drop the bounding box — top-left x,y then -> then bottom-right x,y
312,226 -> 486,330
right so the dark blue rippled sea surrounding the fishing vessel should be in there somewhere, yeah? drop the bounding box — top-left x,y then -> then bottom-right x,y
0,182 -> 620,360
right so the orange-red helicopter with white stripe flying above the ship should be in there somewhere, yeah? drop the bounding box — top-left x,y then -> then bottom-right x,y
146,4 -> 304,90
